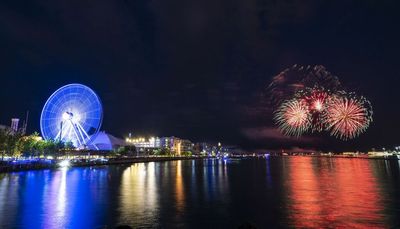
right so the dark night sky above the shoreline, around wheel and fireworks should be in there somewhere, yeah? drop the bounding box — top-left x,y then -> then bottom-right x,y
0,0 -> 400,150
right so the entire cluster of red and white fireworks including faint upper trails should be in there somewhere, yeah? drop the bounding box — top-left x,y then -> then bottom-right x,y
269,65 -> 372,140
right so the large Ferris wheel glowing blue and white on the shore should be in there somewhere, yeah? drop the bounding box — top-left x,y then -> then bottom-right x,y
40,84 -> 103,148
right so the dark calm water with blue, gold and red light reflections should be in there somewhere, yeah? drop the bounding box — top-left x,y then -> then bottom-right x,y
0,157 -> 400,228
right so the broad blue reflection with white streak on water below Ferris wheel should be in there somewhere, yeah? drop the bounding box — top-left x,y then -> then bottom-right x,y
0,168 -> 108,228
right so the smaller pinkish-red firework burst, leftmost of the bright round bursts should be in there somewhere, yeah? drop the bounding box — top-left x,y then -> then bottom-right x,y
274,99 -> 311,136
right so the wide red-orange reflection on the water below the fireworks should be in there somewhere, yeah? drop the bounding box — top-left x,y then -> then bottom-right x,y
287,157 -> 384,228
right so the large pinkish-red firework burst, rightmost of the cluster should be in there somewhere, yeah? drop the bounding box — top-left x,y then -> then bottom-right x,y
324,95 -> 372,140
